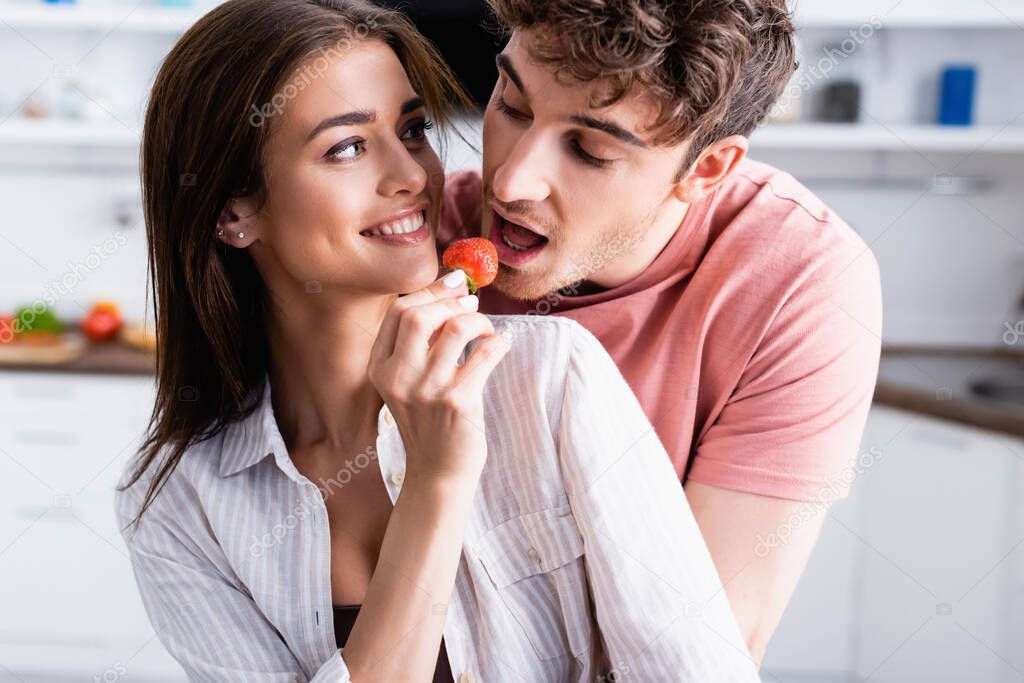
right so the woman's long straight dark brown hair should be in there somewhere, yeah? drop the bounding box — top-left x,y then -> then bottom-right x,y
119,0 -> 471,523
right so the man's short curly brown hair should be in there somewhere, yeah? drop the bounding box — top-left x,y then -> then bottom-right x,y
488,0 -> 797,170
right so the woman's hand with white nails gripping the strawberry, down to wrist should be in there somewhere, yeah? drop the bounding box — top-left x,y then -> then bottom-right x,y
370,270 -> 509,486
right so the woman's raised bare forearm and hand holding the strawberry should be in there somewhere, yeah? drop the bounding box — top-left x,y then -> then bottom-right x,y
344,271 -> 508,683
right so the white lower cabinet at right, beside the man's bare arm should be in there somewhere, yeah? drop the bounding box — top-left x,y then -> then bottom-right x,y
764,407 -> 1024,683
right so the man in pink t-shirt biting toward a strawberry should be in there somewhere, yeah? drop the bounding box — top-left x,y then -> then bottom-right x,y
440,0 -> 881,665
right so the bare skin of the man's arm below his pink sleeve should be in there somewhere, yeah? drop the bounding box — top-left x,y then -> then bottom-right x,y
684,481 -> 827,667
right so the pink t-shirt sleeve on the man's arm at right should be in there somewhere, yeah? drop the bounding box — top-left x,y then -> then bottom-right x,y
689,243 -> 882,503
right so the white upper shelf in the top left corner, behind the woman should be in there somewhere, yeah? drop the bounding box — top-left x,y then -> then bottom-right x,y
0,2 -> 209,34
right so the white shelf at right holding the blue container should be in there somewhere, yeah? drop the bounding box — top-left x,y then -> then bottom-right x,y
751,123 -> 1024,154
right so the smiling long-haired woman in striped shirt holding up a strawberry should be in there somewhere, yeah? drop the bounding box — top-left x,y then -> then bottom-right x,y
117,0 -> 756,683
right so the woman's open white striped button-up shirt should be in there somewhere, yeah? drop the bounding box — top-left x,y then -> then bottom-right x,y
117,316 -> 758,683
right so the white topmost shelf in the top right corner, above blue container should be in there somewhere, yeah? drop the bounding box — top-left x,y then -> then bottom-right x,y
791,0 -> 1024,29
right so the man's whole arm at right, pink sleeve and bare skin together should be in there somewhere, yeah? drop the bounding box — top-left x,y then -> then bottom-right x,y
684,231 -> 882,663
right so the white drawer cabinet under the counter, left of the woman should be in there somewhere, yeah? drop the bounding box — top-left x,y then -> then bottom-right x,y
0,373 -> 184,681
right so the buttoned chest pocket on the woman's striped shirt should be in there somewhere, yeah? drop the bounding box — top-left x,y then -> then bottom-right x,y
474,506 -> 591,659
